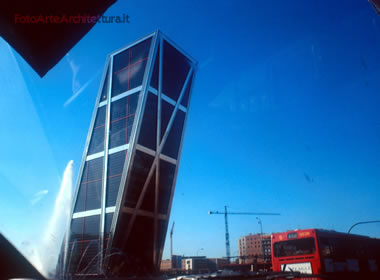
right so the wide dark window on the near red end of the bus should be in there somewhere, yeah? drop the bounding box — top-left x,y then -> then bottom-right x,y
273,238 -> 315,257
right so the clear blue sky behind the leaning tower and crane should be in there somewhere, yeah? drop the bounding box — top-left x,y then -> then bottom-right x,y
0,0 -> 380,258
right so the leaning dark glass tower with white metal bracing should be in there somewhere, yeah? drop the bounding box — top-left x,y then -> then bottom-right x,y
63,31 -> 196,276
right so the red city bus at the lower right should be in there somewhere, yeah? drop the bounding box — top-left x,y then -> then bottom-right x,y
271,229 -> 380,279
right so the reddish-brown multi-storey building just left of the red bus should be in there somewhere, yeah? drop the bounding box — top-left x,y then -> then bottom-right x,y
238,234 -> 271,264
